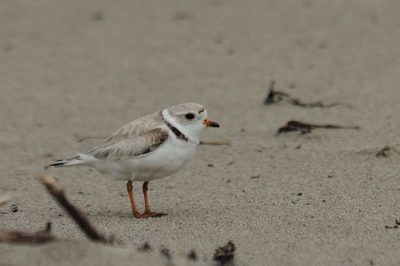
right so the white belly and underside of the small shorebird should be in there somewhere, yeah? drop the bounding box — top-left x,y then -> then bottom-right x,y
93,139 -> 197,181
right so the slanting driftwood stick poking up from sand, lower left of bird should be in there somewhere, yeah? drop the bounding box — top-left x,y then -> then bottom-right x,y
32,172 -> 108,243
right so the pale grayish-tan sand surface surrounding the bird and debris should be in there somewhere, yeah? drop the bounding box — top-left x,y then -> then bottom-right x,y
0,0 -> 400,265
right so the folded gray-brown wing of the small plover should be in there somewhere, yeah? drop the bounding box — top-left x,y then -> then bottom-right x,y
87,128 -> 168,160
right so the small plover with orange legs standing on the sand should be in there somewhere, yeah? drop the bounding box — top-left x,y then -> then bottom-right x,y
49,103 -> 219,218
